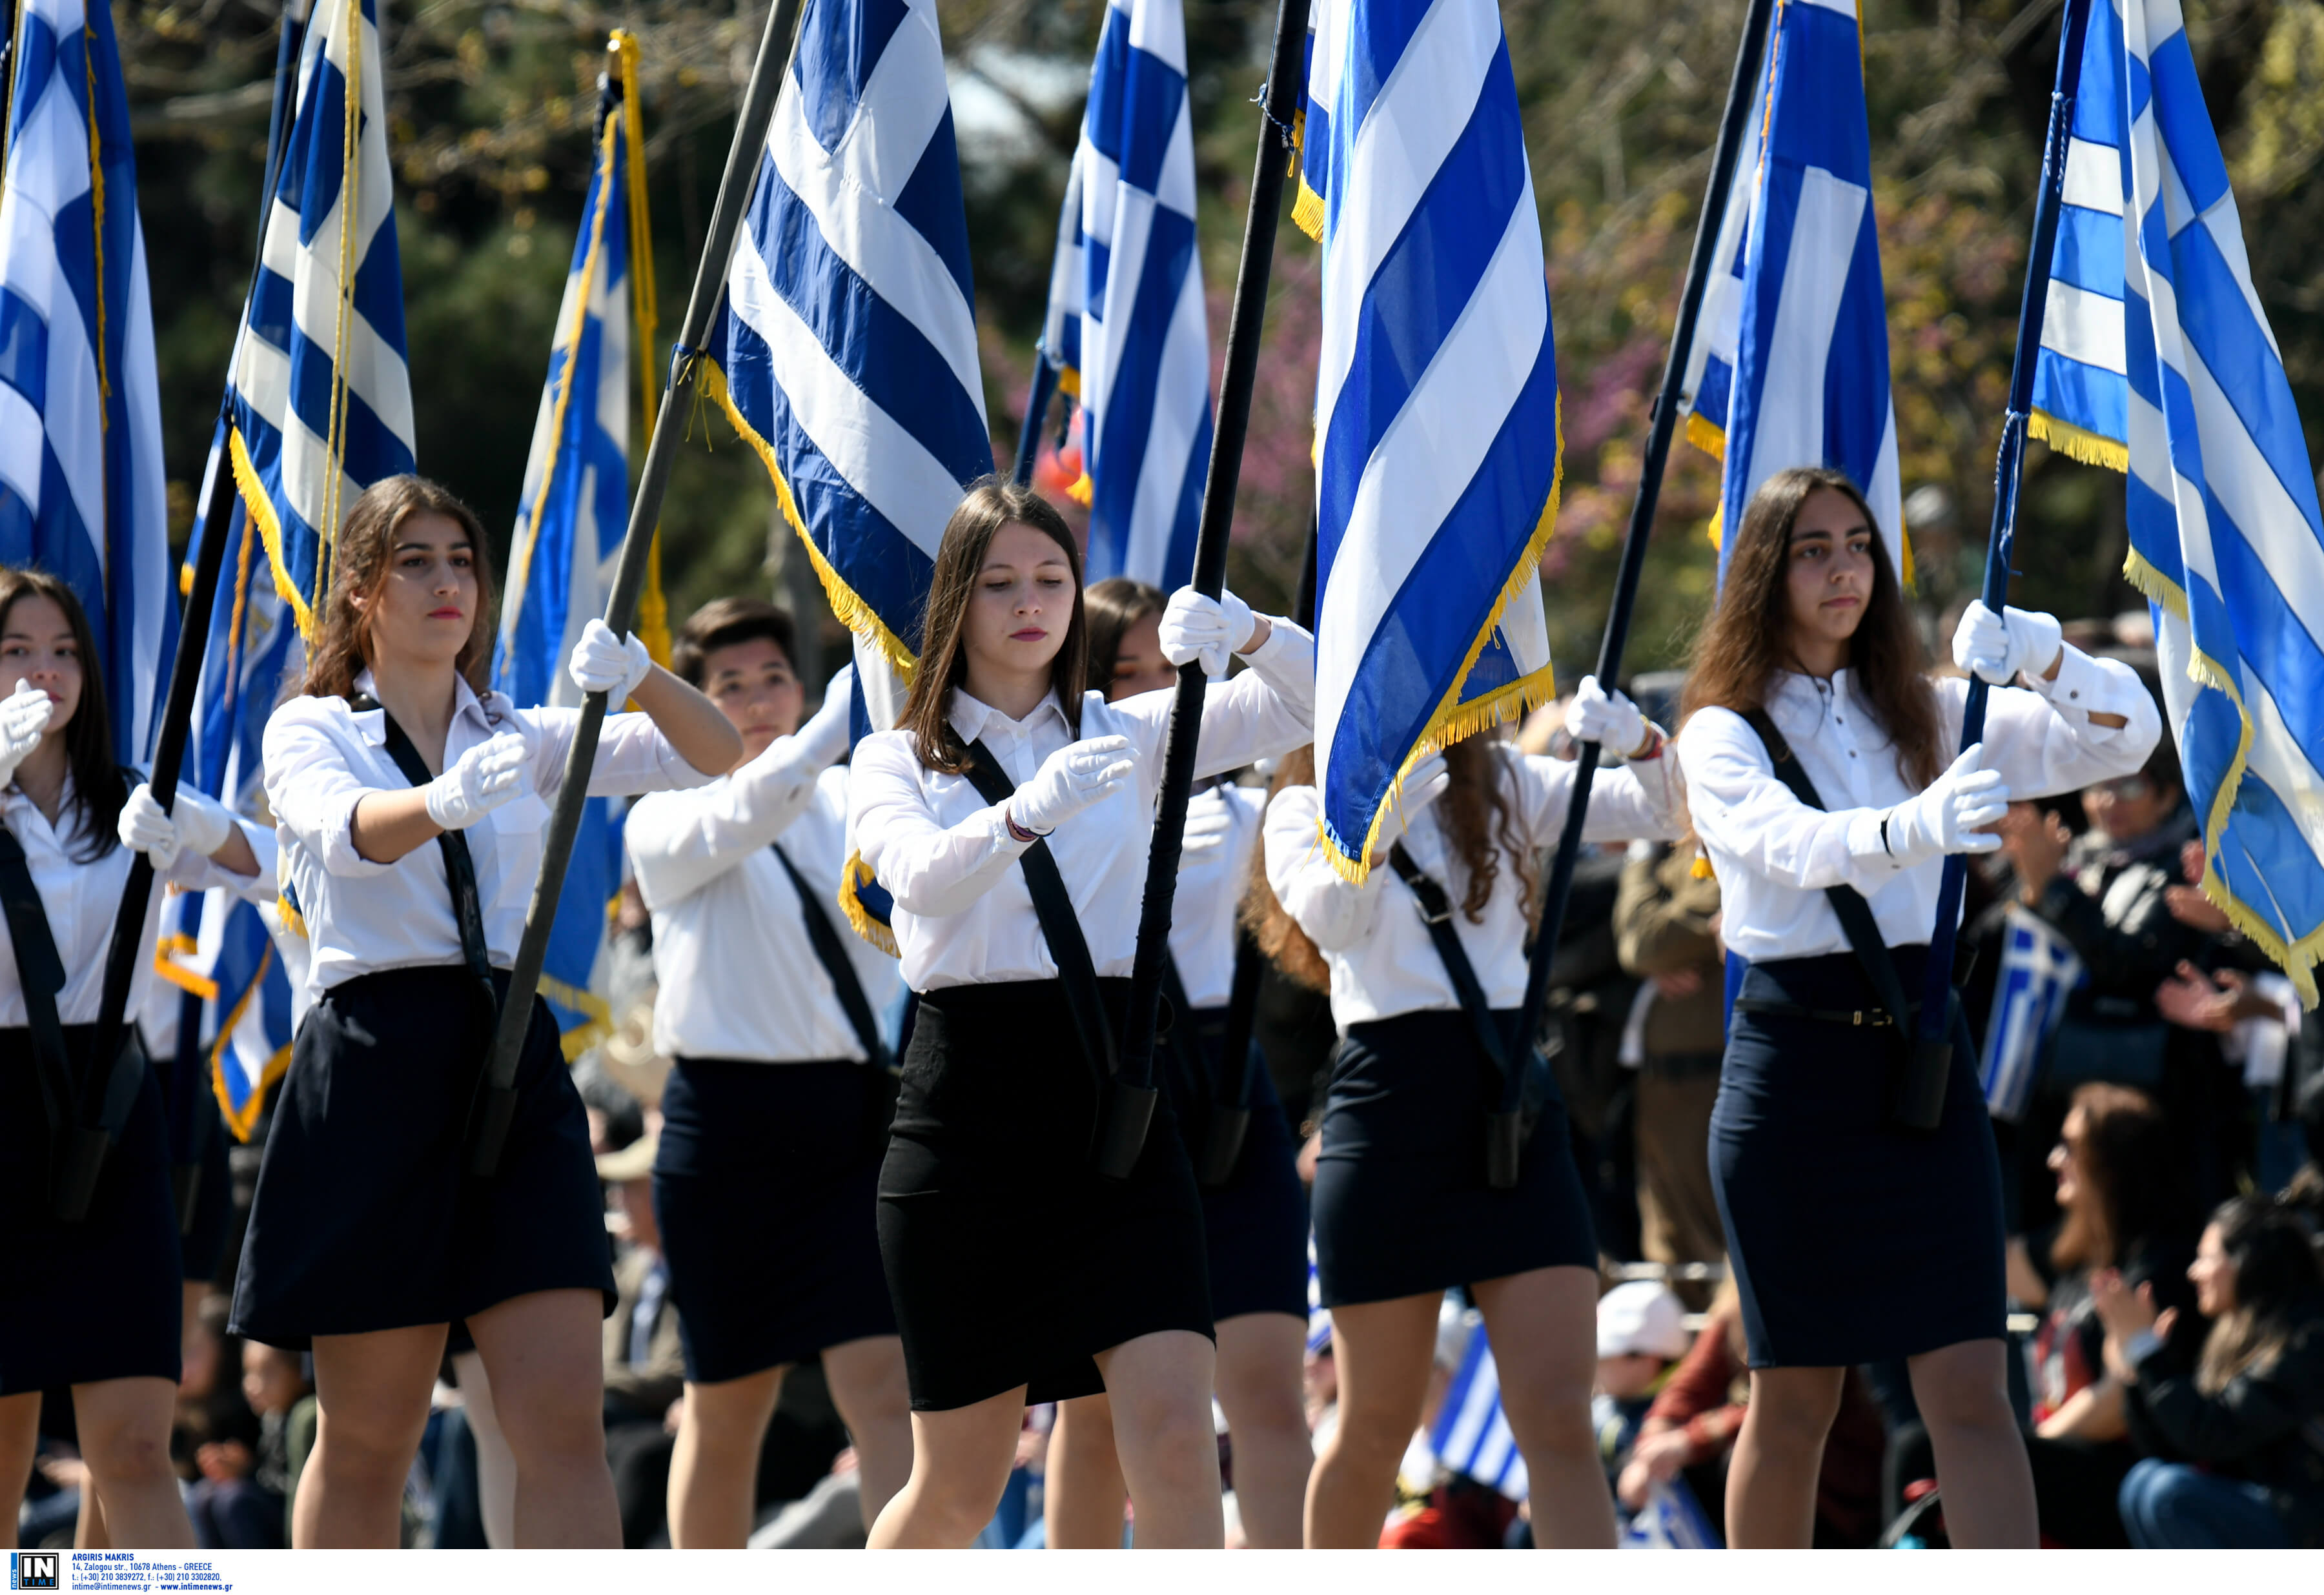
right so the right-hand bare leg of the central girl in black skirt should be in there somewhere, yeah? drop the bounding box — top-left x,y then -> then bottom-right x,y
1097,1330 -> 1227,1551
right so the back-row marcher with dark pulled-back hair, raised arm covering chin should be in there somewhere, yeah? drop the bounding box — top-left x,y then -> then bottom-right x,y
623,598 -> 911,1549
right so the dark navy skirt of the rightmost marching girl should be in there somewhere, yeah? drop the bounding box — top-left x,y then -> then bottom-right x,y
1711,946 -> 2006,1367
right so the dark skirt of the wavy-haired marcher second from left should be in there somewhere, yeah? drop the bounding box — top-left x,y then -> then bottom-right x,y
232,965 -> 613,1351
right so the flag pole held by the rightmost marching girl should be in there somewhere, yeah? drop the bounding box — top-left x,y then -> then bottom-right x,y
1897,0 -> 2089,1130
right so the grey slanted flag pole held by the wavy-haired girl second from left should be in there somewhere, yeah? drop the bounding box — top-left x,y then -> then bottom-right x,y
469,0 -> 804,1177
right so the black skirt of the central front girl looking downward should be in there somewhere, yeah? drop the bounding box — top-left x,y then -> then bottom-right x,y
879,979 -> 1211,1411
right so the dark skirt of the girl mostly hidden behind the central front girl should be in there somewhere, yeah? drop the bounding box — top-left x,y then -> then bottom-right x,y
1157,1009 -> 1306,1323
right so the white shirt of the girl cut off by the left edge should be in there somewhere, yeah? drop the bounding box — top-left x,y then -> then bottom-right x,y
0,774 -> 270,1030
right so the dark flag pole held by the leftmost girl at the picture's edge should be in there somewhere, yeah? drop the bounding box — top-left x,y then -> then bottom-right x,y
56,7 -> 314,1223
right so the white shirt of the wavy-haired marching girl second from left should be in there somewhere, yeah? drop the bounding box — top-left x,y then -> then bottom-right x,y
265,672 -> 709,1000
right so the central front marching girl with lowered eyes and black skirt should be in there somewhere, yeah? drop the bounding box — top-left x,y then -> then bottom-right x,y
848,479 -> 1316,1546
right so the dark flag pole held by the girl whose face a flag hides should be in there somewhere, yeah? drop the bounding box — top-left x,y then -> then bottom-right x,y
1502,0 -> 1775,1088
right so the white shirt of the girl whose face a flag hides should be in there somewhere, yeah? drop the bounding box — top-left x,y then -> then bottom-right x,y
1264,742 -> 1680,1035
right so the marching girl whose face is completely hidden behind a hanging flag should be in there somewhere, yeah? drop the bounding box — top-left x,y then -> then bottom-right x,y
1264,676 -> 1678,1546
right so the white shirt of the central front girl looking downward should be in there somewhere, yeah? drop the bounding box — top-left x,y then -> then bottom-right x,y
848,621 -> 1316,990
